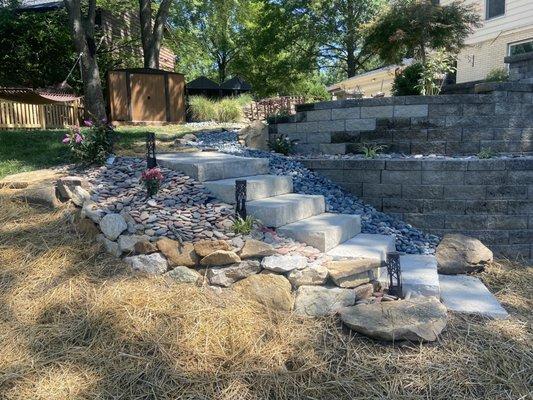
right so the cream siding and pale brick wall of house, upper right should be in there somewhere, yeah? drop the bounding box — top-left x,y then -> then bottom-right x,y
441,0 -> 533,83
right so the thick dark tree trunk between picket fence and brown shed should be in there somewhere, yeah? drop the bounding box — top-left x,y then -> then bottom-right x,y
64,0 -> 106,121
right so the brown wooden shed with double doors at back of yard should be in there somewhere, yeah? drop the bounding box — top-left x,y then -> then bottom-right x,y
107,68 -> 185,123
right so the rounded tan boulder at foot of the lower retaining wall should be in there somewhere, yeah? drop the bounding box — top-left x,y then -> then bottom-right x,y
436,234 -> 493,275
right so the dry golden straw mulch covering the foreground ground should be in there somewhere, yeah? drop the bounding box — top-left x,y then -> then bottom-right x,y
0,198 -> 533,400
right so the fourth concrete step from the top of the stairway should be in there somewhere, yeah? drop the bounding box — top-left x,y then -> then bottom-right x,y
278,213 -> 361,252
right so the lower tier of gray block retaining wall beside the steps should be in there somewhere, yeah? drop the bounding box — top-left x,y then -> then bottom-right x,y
302,157 -> 533,259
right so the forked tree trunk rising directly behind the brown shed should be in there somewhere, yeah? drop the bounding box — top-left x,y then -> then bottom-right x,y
139,0 -> 172,69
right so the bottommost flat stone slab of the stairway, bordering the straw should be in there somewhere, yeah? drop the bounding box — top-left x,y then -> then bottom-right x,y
439,275 -> 509,319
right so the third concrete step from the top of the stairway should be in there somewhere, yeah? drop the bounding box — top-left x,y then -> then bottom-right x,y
246,193 -> 326,228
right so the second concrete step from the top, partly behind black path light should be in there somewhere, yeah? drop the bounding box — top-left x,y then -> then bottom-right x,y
204,175 -> 292,204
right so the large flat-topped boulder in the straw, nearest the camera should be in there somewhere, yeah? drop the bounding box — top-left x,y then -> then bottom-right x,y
340,296 -> 447,341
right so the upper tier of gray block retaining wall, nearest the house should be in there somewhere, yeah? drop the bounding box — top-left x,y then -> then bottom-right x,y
270,90 -> 533,155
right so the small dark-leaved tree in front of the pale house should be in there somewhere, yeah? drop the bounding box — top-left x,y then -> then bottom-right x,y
365,0 -> 480,64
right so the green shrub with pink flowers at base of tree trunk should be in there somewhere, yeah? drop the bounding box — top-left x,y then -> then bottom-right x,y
63,120 -> 114,164
